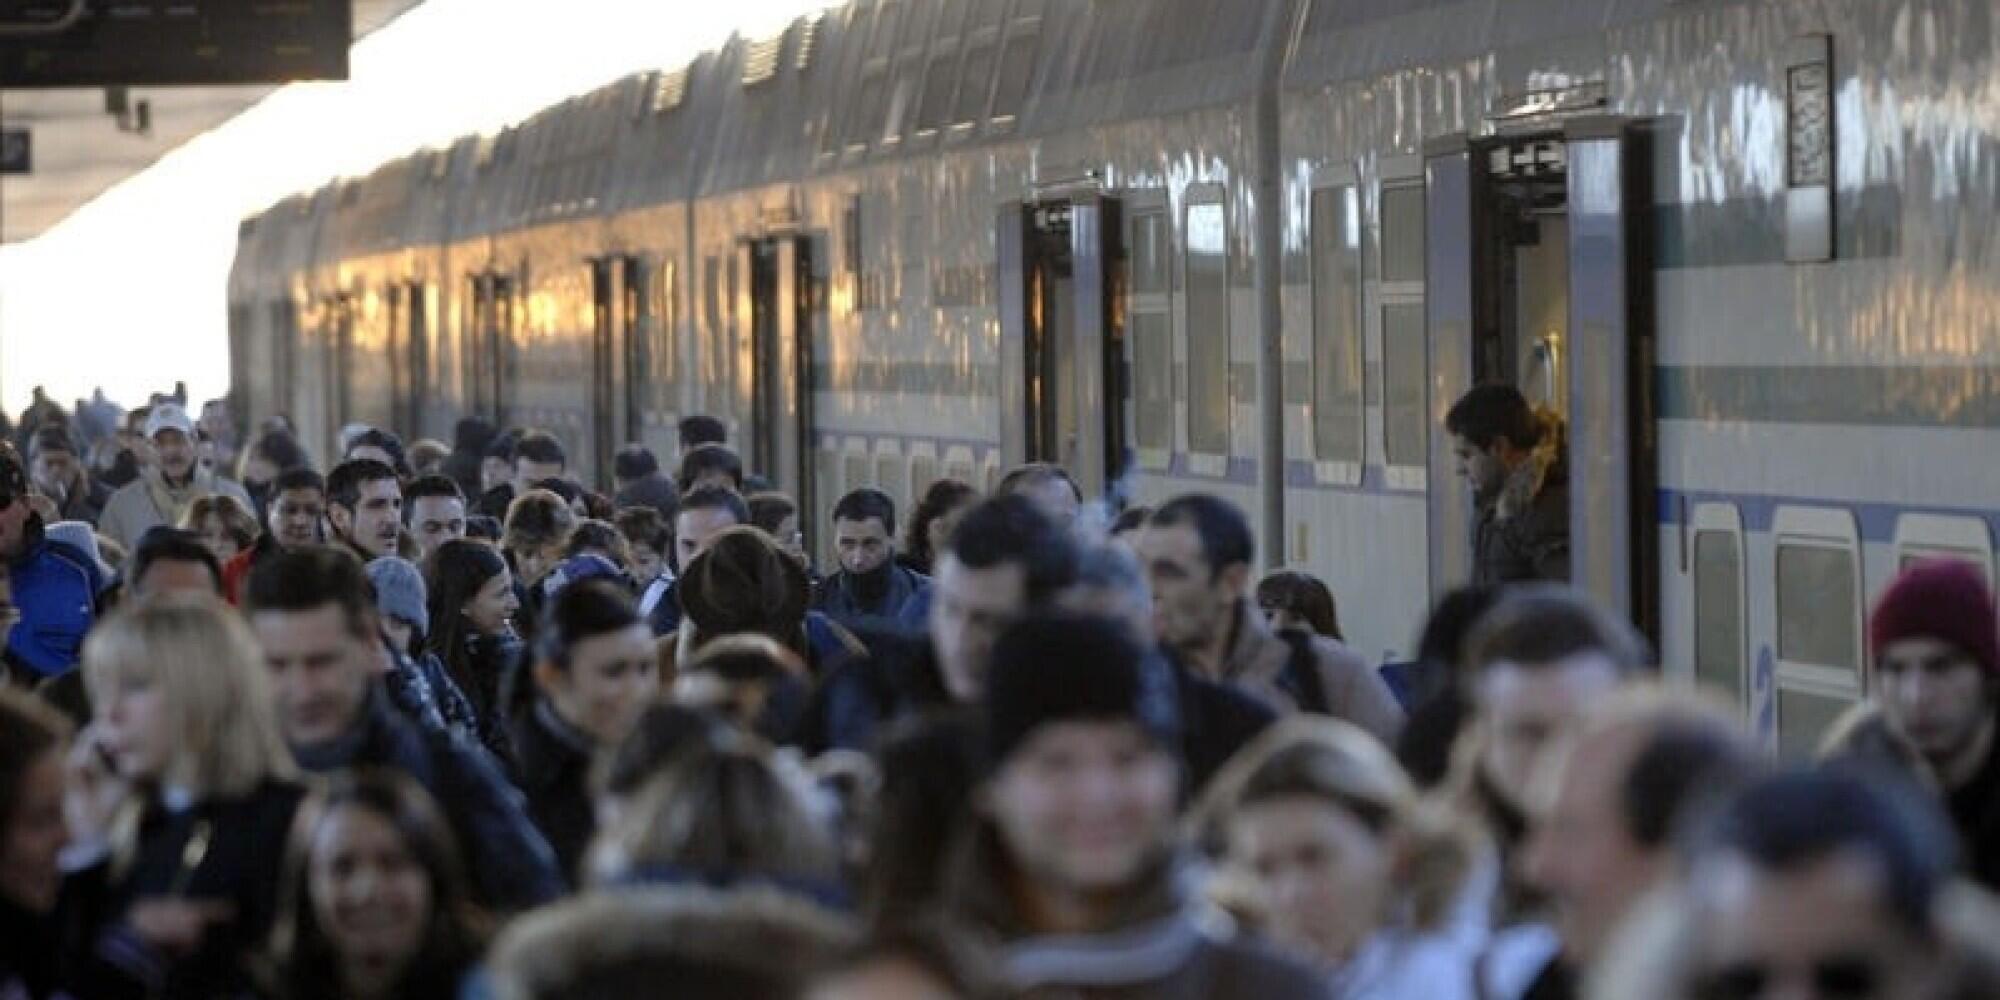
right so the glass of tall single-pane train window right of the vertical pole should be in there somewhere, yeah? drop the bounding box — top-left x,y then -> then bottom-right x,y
1312,186 -> 1364,464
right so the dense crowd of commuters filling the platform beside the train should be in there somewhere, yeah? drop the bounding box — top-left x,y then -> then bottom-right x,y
0,388 -> 2000,1000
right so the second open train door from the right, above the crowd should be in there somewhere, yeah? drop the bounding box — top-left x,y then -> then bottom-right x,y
1000,194 -> 1130,498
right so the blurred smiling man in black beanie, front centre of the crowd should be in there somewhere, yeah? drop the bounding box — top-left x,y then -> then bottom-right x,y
944,616 -> 1330,1000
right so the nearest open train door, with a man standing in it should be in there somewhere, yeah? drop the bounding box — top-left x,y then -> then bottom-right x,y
1426,118 -> 1658,634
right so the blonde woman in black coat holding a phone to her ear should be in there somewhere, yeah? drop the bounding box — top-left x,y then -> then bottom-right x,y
72,596 -> 302,998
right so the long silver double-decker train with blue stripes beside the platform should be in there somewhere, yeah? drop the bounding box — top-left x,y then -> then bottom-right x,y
230,0 -> 2000,754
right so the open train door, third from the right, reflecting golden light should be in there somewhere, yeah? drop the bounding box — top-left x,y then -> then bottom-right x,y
740,236 -> 818,524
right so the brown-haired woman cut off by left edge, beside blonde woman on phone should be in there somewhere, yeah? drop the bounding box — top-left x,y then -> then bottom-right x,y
0,688 -> 70,1000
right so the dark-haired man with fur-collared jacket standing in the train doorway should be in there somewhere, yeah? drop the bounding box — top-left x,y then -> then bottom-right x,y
1444,386 -> 1570,584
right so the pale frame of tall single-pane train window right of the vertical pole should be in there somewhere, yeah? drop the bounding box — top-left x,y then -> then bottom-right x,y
1306,164 -> 1368,486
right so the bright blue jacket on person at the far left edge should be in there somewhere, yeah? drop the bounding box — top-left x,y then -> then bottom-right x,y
6,516 -> 104,678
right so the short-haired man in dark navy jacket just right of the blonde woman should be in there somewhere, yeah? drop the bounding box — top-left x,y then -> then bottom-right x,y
246,544 -> 562,910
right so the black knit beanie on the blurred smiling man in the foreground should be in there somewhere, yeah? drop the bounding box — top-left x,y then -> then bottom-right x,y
986,614 -> 1180,768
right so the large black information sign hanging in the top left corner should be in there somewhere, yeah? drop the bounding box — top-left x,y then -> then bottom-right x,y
0,0 -> 354,90
